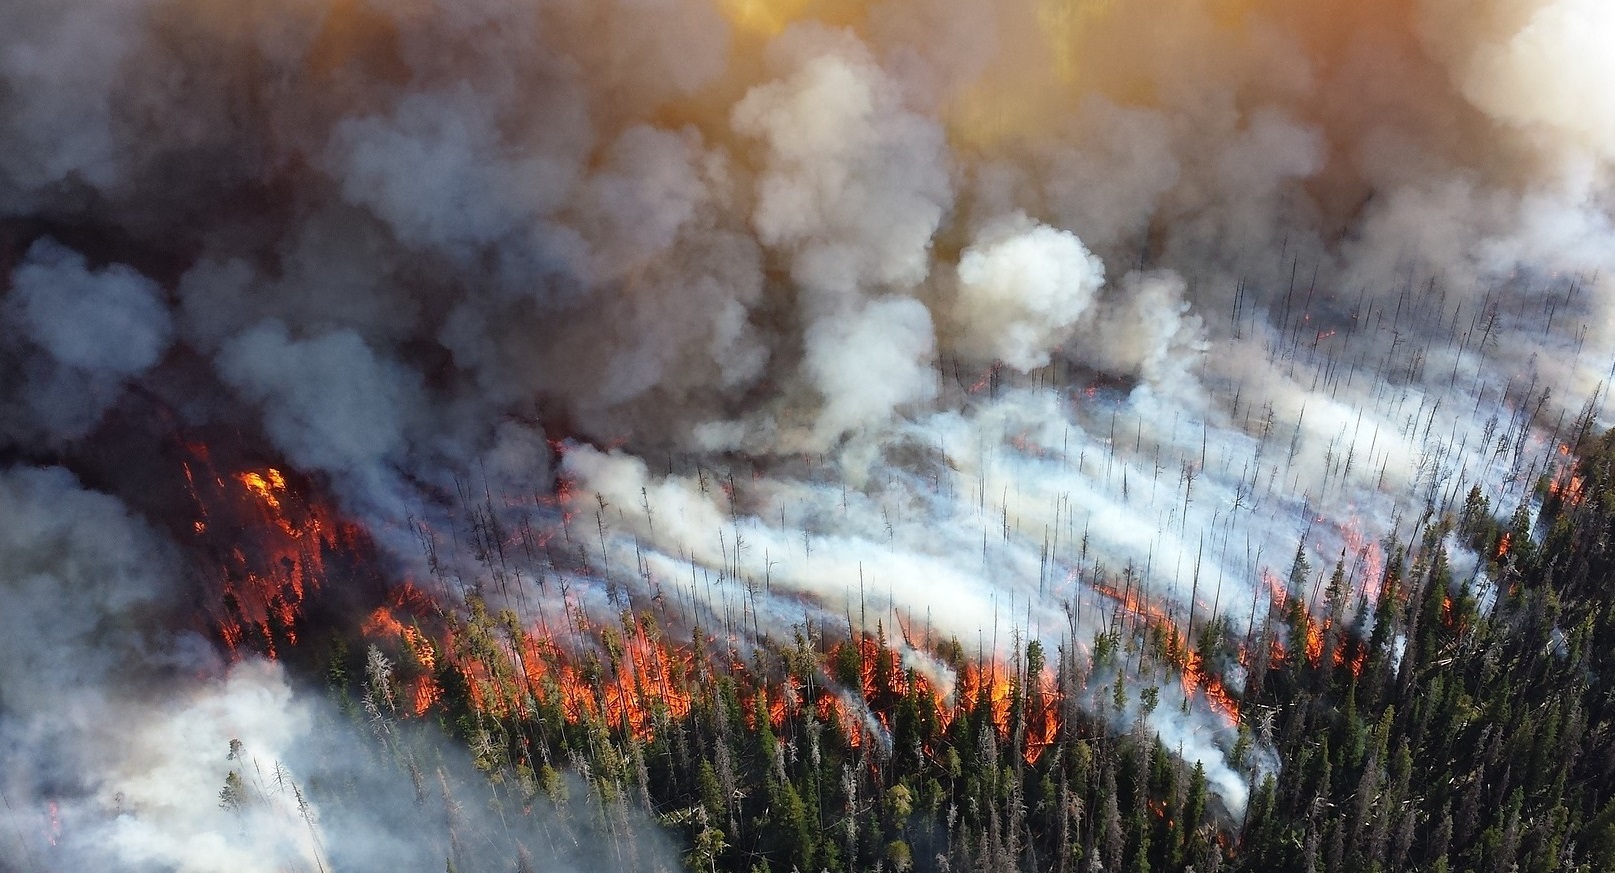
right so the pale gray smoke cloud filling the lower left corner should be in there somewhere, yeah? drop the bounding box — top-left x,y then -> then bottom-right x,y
0,468 -> 677,873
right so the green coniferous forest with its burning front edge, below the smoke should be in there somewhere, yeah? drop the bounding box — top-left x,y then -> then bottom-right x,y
303,422 -> 1615,873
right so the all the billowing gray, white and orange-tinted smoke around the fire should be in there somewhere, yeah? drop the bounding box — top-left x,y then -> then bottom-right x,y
0,0 -> 1615,870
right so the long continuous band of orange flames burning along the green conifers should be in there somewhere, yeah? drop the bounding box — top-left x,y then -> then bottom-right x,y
363,586 -> 1098,763
